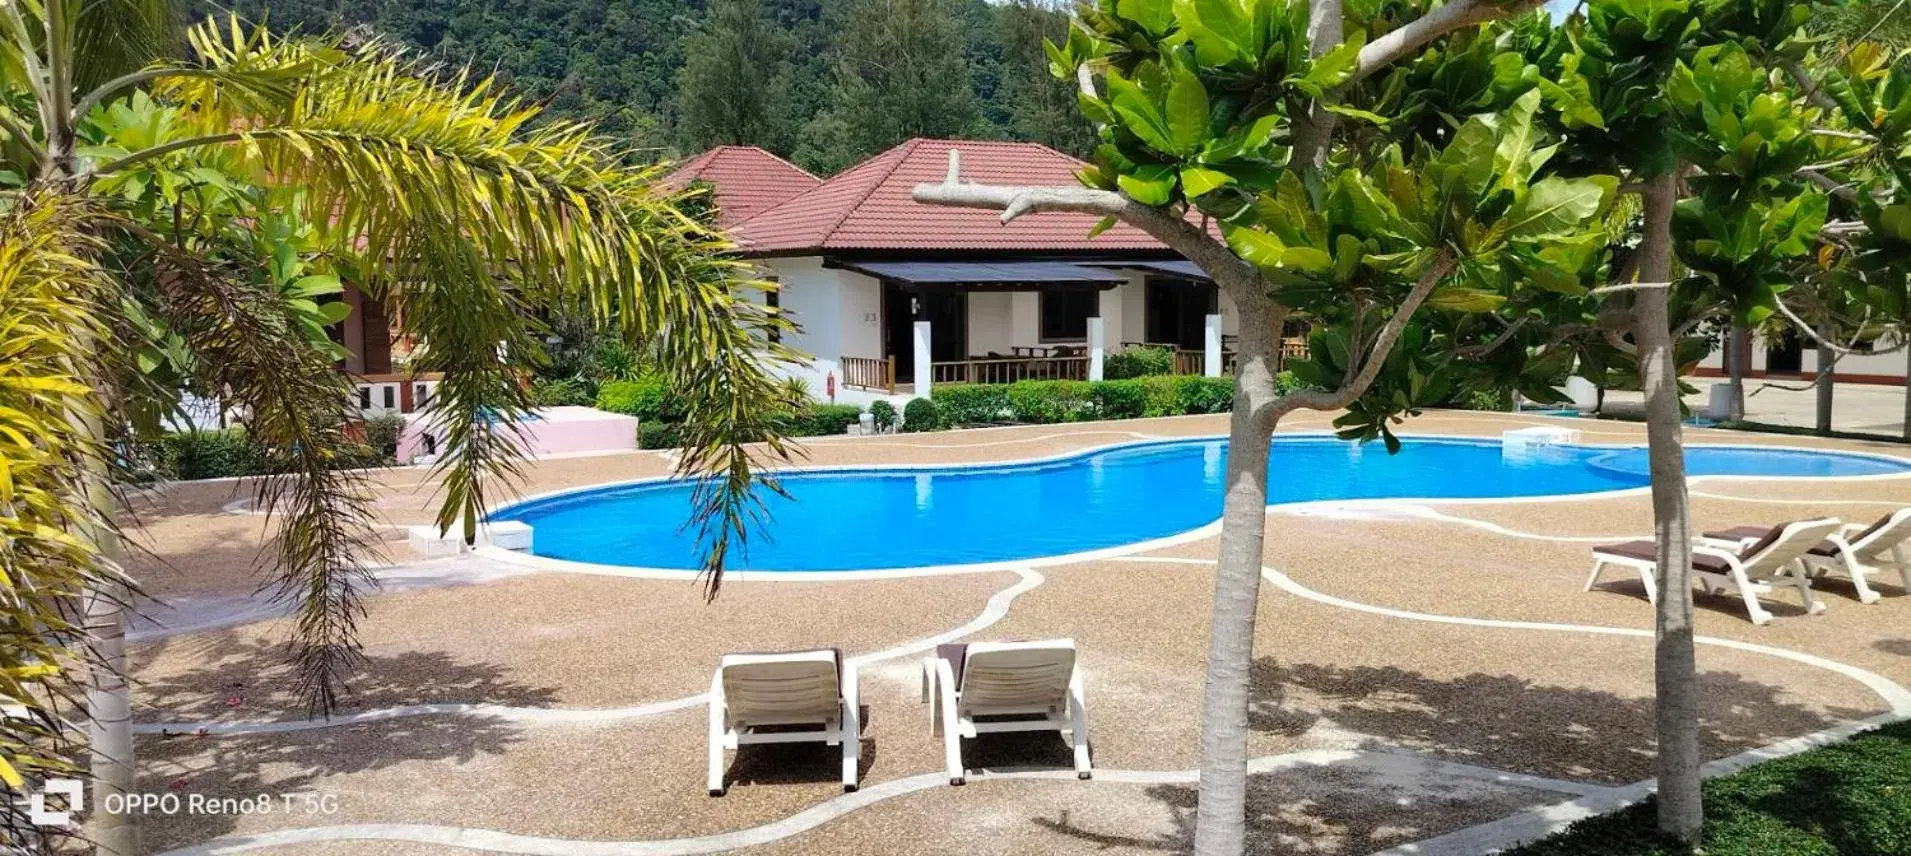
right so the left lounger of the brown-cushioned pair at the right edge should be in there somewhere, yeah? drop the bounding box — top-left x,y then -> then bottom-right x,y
1586,518 -> 1844,625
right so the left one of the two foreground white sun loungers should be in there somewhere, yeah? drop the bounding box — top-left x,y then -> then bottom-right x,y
709,650 -> 862,797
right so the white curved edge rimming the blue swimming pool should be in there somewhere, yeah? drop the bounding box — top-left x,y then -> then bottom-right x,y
472,430 -> 1911,583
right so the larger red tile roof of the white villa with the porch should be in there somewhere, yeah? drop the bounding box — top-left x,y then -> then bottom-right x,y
730,139 -> 1164,256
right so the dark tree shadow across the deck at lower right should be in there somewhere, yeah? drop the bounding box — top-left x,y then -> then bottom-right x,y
1032,657 -> 1875,856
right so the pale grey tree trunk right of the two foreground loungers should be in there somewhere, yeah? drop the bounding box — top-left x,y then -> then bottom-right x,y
1194,298 -> 1280,856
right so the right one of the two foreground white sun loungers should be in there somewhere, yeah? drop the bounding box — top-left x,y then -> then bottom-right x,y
923,638 -> 1093,785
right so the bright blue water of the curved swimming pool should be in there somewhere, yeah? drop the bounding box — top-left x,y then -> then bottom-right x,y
493,438 -> 1911,571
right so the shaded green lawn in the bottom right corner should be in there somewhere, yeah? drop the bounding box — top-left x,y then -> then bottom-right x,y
1508,722 -> 1911,856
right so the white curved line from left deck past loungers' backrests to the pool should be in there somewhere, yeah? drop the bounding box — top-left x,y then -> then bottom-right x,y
134,567 -> 1045,736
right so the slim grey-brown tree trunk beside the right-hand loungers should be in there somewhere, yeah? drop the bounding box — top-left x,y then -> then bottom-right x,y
1632,172 -> 1705,841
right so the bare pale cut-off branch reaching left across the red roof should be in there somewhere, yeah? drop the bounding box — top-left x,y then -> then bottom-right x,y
912,149 -> 1267,292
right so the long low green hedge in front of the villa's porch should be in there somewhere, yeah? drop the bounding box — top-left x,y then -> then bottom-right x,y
929,375 -> 1235,424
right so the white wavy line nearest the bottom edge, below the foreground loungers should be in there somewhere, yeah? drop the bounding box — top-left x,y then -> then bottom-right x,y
145,749 -> 1613,856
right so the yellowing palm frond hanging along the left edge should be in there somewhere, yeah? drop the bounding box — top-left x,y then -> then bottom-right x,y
0,187 -> 126,829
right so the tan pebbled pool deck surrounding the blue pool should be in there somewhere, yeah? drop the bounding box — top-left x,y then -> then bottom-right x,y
123,411 -> 1911,856
